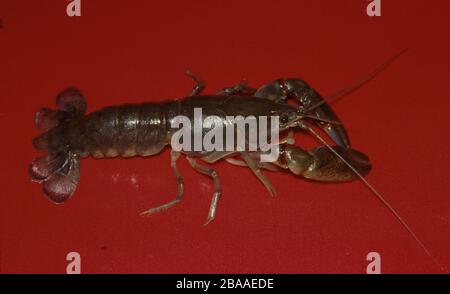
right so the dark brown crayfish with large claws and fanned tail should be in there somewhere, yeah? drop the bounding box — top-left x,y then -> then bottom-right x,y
29,73 -> 371,223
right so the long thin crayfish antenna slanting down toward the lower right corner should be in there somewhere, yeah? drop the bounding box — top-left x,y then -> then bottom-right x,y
299,122 -> 445,271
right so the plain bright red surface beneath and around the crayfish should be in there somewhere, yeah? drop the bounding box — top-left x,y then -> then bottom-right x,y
0,0 -> 450,273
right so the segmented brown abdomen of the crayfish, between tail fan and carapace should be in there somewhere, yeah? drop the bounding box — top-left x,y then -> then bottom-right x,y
69,102 -> 175,158
